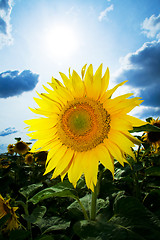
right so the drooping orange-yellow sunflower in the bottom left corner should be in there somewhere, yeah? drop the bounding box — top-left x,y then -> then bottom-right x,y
0,194 -> 19,231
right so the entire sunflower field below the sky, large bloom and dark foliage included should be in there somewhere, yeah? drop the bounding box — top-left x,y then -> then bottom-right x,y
0,65 -> 160,240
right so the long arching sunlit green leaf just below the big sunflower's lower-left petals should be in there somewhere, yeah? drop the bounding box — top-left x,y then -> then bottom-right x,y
29,181 -> 79,204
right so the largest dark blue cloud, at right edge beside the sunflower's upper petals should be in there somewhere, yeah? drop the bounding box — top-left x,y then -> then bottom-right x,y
115,41 -> 160,116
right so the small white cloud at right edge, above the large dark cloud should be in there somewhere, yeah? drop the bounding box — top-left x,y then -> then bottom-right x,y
141,14 -> 160,39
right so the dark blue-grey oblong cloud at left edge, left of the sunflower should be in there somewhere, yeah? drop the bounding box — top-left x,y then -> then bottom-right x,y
0,70 -> 39,98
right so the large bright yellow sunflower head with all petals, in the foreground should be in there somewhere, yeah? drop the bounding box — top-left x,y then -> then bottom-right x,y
25,64 -> 146,191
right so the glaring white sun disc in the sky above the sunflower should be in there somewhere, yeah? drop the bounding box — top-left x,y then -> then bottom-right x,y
44,24 -> 78,58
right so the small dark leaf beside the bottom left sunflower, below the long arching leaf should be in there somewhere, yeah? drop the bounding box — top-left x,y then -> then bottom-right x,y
22,206 -> 46,224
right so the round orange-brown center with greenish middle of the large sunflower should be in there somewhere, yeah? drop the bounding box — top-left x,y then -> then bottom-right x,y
58,97 -> 110,152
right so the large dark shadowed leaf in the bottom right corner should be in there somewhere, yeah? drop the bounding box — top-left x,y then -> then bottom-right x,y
110,195 -> 160,240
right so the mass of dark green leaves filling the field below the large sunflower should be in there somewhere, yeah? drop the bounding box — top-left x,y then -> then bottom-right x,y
0,131 -> 160,240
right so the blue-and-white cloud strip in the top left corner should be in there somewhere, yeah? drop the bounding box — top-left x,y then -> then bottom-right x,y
0,0 -> 13,49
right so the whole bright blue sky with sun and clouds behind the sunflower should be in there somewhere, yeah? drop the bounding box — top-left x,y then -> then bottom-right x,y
0,0 -> 160,152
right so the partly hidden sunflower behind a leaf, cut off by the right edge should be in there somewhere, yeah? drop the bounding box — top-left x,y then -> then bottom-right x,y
143,118 -> 160,152
